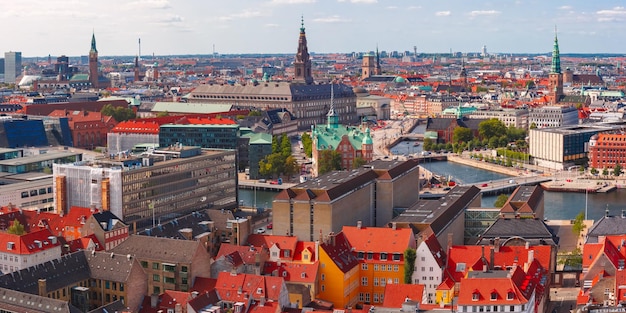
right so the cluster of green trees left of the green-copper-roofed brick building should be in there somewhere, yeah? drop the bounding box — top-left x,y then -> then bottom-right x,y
259,134 -> 300,178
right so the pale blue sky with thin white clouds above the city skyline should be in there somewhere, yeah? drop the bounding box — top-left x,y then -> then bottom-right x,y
0,0 -> 626,57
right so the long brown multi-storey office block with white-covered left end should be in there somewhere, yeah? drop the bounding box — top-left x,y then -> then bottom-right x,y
53,146 -> 237,229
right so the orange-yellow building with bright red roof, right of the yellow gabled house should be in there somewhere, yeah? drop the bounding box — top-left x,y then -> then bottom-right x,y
342,223 -> 416,305
